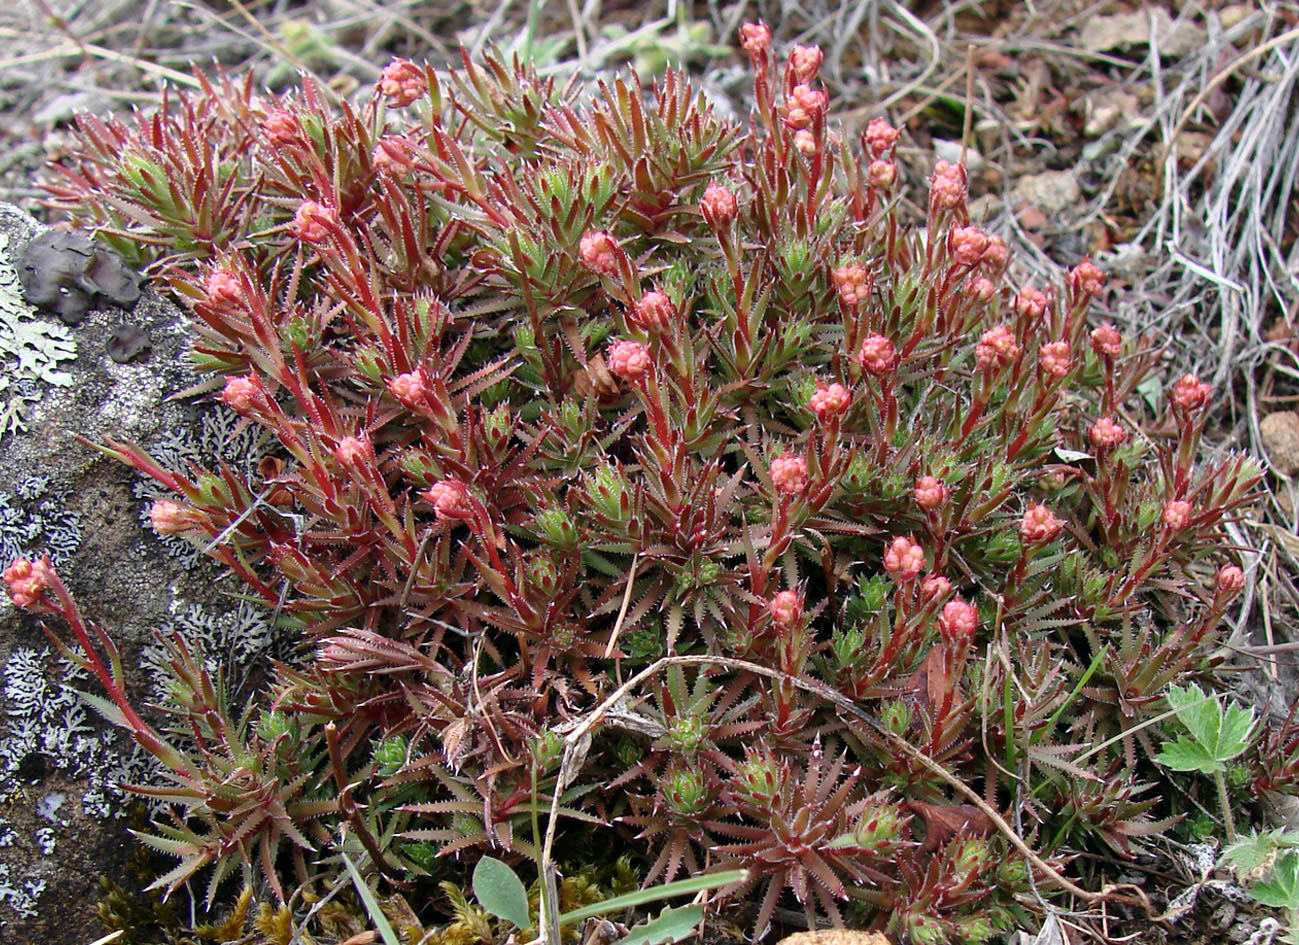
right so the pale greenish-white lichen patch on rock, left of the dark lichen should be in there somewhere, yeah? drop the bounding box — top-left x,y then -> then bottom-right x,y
0,233 -> 77,439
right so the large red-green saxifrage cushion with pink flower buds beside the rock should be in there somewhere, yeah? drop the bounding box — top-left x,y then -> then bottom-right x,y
6,25 -> 1273,942
